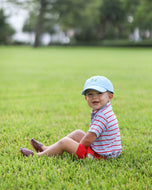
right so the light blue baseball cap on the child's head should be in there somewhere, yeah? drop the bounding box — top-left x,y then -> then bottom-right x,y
82,76 -> 114,95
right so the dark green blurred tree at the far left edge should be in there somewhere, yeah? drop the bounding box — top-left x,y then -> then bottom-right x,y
0,9 -> 15,44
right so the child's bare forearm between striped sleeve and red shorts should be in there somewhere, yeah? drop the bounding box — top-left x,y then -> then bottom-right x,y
80,132 -> 97,147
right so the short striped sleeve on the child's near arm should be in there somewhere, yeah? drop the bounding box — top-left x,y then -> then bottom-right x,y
89,115 -> 107,138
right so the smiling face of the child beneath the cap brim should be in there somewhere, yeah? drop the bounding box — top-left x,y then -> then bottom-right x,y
85,89 -> 113,111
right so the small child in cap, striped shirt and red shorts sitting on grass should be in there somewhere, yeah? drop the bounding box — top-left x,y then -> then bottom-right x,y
20,76 -> 122,159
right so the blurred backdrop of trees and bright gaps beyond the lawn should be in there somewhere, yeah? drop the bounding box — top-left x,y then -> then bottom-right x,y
0,0 -> 152,47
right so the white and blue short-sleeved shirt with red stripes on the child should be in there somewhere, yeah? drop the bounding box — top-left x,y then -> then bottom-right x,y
89,102 -> 122,158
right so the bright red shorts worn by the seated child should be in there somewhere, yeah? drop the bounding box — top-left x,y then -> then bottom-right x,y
76,144 -> 106,159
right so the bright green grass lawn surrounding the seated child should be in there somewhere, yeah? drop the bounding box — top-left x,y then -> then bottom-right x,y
0,47 -> 152,190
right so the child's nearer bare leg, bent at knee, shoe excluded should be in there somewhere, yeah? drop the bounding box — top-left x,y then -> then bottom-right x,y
37,135 -> 79,156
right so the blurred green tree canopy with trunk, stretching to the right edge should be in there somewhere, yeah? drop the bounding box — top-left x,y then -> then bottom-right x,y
4,0 -> 152,47
